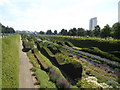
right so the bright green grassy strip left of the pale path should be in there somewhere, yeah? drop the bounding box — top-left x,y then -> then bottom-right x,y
2,35 -> 19,88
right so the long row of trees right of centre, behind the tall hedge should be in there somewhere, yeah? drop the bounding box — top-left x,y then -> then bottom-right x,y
39,22 -> 120,39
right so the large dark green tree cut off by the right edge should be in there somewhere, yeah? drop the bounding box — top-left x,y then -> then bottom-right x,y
112,22 -> 120,39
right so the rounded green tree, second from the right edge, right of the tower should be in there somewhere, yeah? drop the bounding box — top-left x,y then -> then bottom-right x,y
100,24 -> 111,38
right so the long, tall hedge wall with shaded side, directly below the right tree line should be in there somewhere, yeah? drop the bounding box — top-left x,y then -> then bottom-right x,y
38,35 -> 120,52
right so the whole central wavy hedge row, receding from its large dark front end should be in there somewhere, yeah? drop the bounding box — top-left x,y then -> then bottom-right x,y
36,40 -> 82,79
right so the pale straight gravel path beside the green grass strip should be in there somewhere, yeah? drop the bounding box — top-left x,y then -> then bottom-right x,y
19,38 -> 35,88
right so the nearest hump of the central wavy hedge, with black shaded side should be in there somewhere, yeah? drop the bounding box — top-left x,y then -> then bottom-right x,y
56,54 -> 82,79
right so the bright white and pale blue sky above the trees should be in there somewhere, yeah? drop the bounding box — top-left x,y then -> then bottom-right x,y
0,0 -> 119,32
